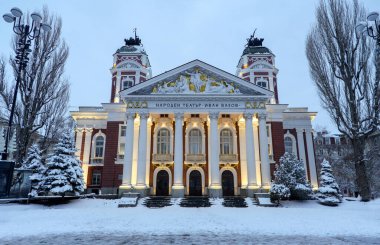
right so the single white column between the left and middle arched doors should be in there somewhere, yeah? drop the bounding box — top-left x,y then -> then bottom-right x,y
173,113 -> 184,189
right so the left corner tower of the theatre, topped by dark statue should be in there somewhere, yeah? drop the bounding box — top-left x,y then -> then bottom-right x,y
111,30 -> 152,103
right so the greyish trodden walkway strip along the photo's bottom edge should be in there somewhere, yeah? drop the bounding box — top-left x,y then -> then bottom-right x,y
0,233 -> 380,245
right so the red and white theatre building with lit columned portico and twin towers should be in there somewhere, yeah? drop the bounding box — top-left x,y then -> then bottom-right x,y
71,33 -> 318,197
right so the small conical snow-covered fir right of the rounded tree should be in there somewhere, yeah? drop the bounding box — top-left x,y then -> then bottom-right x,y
317,159 -> 342,206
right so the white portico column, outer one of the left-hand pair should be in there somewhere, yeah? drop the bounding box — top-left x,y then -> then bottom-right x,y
122,112 -> 135,188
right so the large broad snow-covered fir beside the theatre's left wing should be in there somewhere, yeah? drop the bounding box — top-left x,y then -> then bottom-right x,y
41,132 -> 84,196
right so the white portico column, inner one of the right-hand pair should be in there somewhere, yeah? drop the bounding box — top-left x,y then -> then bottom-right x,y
244,112 -> 257,189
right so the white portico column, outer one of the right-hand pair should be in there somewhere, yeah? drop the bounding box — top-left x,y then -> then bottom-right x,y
259,113 -> 271,188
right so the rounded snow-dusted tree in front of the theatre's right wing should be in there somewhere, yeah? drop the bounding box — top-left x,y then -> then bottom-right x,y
273,152 -> 312,200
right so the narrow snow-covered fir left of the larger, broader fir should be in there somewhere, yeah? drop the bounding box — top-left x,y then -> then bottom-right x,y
22,144 -> 46,197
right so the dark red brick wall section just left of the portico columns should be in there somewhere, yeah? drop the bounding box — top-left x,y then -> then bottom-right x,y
102,121 -> 124,187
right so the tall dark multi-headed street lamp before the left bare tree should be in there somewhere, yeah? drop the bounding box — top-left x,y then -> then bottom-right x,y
1,8 -> 51,160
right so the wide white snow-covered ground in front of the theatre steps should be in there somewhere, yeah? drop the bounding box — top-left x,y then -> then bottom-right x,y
0,199 -> 380,239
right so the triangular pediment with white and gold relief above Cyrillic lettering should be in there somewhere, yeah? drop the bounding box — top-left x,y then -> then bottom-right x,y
120,60 -> 273,97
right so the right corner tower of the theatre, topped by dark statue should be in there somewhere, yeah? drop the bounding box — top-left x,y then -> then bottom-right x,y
236,33 -> 279,104
